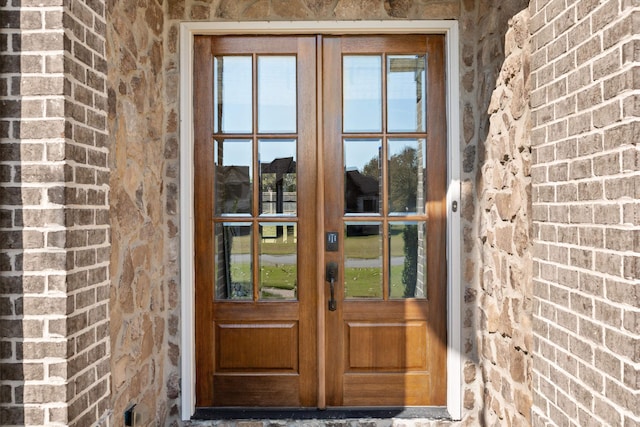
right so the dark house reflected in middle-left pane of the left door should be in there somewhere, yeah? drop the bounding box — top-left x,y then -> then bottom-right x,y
217,166 -> 251,213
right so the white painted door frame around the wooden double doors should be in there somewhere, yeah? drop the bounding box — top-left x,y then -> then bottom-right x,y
179,20 -> 465,421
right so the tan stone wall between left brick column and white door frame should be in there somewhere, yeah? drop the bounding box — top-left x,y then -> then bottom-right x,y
107,0 -> 180,425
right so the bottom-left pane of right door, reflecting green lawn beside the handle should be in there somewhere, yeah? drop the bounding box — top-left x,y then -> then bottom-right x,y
344,222 -> 382,298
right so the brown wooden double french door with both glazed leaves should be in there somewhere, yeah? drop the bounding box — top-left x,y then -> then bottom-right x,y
194,35 -> 447,408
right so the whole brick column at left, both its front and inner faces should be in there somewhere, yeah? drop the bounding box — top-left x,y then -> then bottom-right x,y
0,0 -> 110,425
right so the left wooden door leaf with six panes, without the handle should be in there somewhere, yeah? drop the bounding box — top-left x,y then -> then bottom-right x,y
194,36 -> 318,407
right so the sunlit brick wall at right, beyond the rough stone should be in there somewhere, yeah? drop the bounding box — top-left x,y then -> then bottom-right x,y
529,0 -> 640,426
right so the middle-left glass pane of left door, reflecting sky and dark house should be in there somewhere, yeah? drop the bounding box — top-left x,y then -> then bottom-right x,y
214,139 -> 252,215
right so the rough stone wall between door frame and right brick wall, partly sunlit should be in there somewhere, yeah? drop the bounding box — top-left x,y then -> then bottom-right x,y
461,1 -> 532,425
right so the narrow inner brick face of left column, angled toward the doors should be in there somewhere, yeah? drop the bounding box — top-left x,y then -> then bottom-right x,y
63,0 -> 111,426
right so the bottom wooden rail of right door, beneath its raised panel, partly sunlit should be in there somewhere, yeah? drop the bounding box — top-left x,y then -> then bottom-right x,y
343,373 -> 430,406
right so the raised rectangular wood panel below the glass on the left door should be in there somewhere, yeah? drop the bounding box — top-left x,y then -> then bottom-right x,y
216,323 -> 298,372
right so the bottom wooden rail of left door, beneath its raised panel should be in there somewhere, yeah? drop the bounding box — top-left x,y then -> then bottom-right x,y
213,375 -> 298,407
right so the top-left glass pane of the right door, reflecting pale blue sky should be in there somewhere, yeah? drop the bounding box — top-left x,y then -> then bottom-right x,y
342,55 -> 382,132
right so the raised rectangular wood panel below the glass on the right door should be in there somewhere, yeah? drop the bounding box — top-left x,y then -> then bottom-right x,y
345,322 -> 427,371
